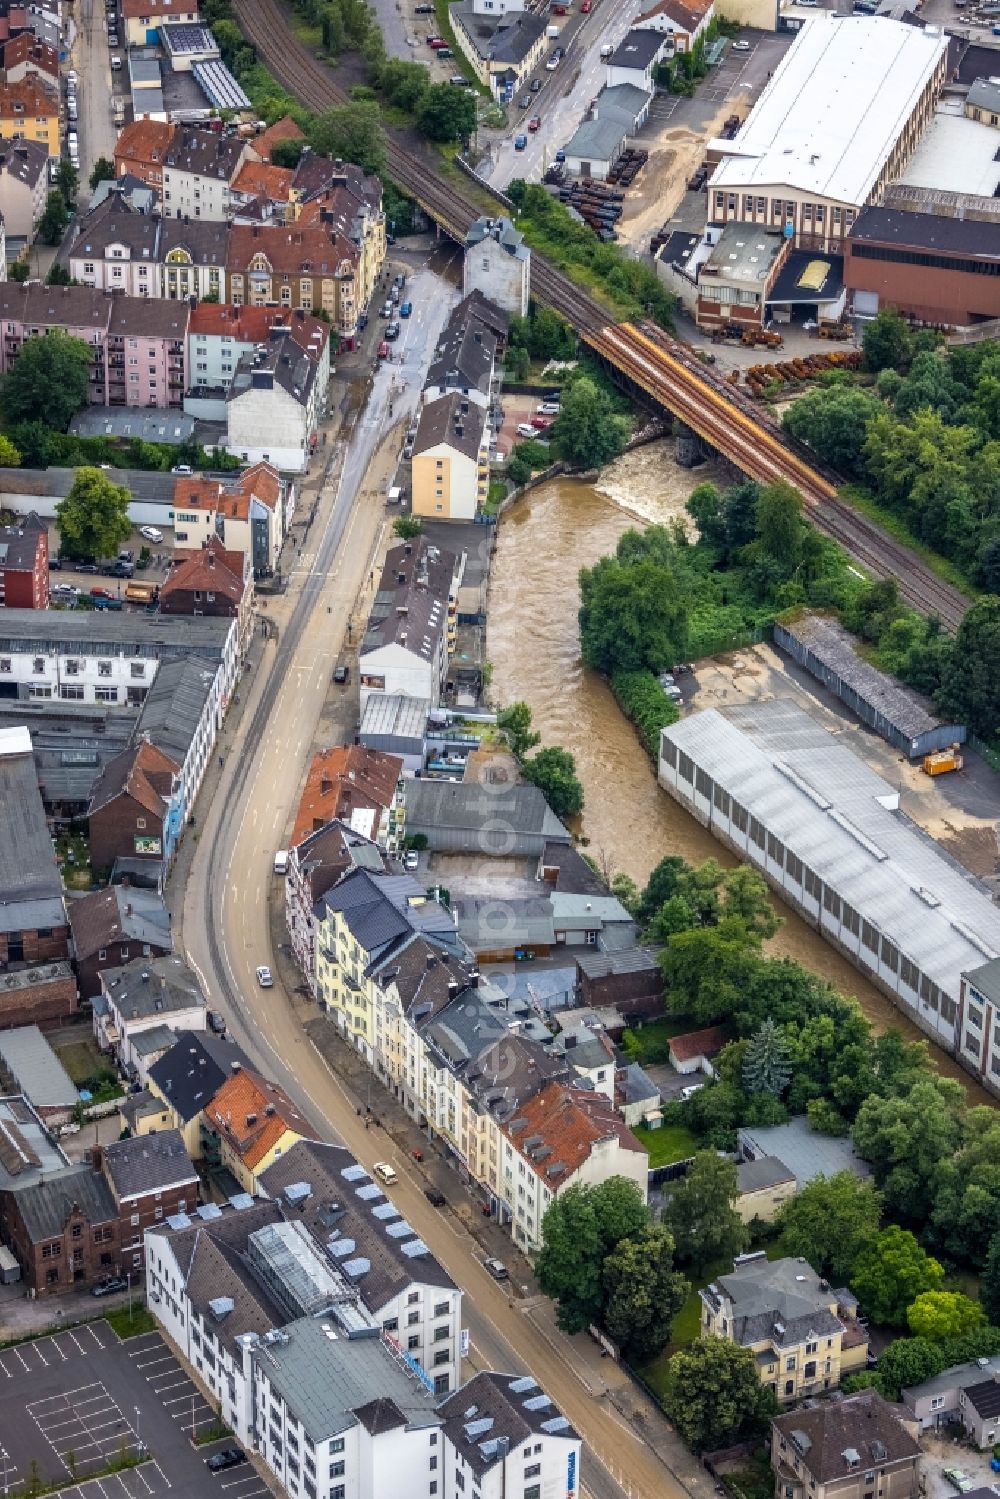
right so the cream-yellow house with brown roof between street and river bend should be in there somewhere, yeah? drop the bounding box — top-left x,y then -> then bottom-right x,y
411,391 -> 493,520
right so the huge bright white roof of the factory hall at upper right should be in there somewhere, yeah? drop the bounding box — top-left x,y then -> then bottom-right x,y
711,16 -> 947,205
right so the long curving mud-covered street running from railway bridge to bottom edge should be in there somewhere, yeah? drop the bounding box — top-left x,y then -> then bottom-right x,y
172,245 -> 712,1499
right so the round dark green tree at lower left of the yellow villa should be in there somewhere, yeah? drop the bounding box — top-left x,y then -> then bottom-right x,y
663,1337 -> 778,1453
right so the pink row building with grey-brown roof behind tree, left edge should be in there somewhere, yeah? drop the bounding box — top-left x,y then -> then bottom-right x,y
0,282 -> 190,408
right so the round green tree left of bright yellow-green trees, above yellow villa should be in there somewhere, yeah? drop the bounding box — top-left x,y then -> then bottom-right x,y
778,1171 -> 882,1286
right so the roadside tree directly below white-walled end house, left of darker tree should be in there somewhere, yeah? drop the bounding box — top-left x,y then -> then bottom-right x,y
535,1177 -> 649,1333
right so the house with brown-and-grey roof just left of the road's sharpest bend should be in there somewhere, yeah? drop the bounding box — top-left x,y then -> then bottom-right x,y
69,884 -> 172,1000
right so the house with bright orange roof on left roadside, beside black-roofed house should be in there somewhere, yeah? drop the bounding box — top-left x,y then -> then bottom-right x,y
202,1067 -> 322,1195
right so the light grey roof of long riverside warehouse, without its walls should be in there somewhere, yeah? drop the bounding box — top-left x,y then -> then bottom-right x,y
661,699 -> 1000,1007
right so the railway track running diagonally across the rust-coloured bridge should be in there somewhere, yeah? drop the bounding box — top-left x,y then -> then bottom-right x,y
234,0 -> 967,630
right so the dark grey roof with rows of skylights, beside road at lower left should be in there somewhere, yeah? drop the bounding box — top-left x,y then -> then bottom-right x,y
258,1139 -> 454,1312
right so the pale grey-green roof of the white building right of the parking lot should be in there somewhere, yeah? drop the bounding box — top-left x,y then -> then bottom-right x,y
253,1318 -> 441,1442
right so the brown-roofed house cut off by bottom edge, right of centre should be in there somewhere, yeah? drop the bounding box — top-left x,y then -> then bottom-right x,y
771,1390 -> 921,1499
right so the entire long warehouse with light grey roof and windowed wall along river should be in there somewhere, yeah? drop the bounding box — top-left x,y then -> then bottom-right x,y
660,699 -> 1000,1081
